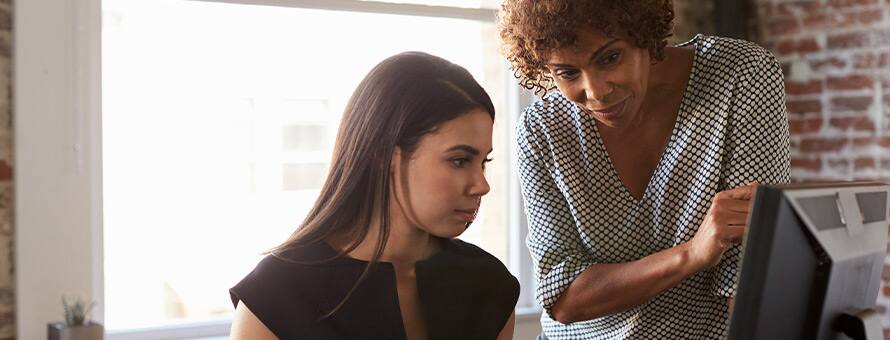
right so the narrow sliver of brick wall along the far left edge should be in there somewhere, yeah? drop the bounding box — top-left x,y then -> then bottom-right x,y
0,0 -> 15,340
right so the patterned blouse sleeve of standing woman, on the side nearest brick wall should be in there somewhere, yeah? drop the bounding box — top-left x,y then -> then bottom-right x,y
714,46 -> 790,297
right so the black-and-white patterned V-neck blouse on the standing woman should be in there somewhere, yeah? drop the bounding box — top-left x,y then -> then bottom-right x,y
517,35 -> 789,339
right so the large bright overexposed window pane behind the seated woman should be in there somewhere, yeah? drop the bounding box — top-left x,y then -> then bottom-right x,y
102,0 -> 509,329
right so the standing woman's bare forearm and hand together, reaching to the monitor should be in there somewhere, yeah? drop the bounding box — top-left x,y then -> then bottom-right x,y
551,183 -> 757,323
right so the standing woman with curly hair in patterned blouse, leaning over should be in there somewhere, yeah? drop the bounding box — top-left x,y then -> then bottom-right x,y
498,0 -> 789,339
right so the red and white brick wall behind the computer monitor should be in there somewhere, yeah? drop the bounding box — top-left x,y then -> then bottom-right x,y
753,0 -> 890,339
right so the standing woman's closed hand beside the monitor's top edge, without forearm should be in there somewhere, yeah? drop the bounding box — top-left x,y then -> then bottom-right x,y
687,182 -> 757,271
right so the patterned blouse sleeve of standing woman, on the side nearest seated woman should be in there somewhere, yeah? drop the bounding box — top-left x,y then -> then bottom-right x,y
516,107 -> 593,318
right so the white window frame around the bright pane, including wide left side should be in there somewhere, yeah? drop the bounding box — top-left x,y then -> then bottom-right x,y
11,0 -> 540,340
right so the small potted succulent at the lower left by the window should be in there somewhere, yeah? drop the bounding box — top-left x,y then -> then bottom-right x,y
47,296 -> 105,340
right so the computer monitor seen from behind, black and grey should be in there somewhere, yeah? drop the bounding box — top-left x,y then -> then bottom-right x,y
729,182 -> 890,340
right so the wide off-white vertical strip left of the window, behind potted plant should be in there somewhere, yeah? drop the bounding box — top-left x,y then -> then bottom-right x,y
13,0 -> 102,339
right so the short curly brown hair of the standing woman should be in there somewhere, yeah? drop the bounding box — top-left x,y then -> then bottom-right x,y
498,0 -> 674,94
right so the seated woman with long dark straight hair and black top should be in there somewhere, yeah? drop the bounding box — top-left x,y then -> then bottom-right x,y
230,52 -> 519,340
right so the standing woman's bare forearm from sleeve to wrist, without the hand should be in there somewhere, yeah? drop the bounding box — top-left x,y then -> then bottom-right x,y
552,243 -> 706,323
